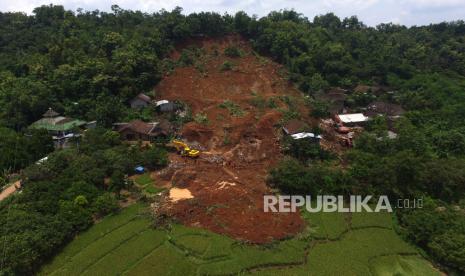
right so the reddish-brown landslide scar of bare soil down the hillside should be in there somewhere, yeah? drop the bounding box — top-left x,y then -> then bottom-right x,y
154,36 -> 315,243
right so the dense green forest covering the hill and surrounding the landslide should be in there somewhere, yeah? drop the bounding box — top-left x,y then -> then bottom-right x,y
0,5 -> 465,275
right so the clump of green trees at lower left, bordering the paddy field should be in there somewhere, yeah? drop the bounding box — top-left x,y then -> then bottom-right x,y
0,128 -> 166,274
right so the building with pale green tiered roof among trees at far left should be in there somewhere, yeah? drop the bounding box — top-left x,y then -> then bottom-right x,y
29,108 -> 86,148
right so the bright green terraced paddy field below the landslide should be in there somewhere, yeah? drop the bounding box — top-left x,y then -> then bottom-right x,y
39,204 -> 440,276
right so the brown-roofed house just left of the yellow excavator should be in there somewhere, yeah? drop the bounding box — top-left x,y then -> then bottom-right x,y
113,120 -> 172,141
